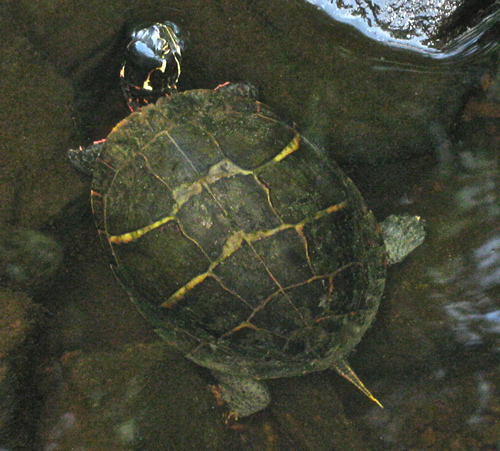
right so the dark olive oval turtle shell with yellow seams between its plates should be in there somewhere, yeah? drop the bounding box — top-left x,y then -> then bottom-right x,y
92,90 -> 385,378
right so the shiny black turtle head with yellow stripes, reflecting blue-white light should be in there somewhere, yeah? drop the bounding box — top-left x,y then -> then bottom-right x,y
120,22 -> 186,111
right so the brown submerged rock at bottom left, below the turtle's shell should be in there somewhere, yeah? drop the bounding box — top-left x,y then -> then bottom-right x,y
40,343 -> 225,450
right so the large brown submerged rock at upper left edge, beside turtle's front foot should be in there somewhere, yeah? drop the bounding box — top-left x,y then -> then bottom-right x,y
0,5 -> 83,230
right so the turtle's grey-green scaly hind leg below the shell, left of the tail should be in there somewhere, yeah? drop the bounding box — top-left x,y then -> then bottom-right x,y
212,371 -> 271,418
